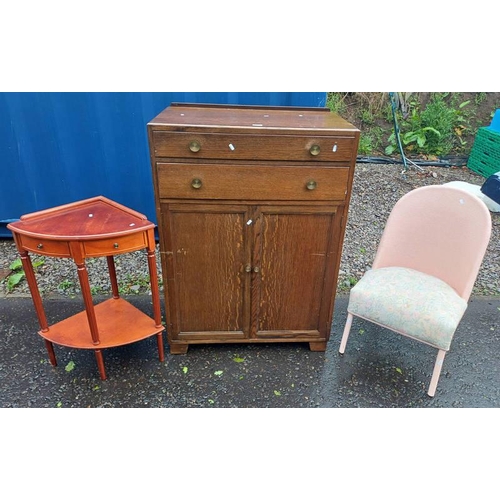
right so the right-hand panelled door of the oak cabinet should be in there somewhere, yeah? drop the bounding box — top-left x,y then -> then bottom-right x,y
252,207 -> 337,338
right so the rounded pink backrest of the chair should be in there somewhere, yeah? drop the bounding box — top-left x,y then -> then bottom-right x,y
373,185 -> 491,300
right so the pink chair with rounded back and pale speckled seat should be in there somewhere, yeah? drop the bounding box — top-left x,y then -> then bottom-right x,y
339,186 -> 491,397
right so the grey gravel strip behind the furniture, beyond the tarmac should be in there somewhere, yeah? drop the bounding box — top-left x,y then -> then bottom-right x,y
0,163 -> 500,297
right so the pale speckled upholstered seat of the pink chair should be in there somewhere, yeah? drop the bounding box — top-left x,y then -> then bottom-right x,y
347,267 -> 467,351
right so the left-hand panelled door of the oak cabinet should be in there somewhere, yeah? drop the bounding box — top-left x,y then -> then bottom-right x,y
164,204 -> 250,339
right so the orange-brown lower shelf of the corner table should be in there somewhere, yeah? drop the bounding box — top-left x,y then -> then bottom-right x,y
38,298 -> 165,349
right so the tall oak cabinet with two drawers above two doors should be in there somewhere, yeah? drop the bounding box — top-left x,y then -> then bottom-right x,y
148,104 -> 359,354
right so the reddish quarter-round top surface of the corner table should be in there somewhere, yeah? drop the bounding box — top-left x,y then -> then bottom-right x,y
7,196 -> 155,240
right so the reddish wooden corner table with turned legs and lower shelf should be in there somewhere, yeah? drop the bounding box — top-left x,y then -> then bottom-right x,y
7,196 -> 165,380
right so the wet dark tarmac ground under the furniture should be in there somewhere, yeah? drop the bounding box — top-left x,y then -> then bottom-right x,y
0,295 -> 500,408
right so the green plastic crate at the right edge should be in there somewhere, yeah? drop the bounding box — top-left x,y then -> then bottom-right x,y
467,127 -> 500,177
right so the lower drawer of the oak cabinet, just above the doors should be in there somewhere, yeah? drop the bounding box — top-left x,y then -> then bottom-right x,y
157,163 -> 349,201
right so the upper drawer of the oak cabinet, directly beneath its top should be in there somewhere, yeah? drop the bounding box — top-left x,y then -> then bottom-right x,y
152,131 -> 355,162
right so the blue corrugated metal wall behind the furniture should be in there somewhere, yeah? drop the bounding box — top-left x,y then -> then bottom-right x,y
0,92 -> 326,237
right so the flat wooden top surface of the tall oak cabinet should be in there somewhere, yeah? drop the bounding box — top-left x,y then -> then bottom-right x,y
148,103 -> 359,135
